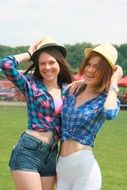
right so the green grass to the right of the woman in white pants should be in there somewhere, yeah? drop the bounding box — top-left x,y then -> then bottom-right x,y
94,111 -> 127,190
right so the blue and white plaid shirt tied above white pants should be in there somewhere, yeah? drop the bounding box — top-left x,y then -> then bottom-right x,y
62,93 -> 120,147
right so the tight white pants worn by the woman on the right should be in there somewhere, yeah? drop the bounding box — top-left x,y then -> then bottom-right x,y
56,150 -> 102,190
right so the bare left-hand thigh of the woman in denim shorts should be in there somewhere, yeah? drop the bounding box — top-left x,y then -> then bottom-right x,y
12,170 -> 42,190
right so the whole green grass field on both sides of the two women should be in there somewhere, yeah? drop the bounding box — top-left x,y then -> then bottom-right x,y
0,106 -> 127,190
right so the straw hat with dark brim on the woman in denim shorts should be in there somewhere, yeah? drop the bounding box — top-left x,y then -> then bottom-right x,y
31,36 -> 67,60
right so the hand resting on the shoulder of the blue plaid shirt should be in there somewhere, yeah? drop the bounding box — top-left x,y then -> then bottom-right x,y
67,79 -> 84,95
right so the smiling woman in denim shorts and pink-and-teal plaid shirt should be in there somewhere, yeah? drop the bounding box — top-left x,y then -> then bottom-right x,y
0,37 -> 72,190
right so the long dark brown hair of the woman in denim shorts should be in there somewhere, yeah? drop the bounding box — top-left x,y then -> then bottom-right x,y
24,47 -> 73,87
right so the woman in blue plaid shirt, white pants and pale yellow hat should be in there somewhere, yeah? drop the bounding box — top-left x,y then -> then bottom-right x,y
57,43 -> 122,190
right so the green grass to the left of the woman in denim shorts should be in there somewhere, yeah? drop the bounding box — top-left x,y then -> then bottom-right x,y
0,106 -> 26,190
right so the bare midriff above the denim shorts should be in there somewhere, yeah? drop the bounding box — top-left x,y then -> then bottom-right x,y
25,129 -> 53,144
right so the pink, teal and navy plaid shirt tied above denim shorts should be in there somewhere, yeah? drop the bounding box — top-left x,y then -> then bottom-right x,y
0,56 -> 64,141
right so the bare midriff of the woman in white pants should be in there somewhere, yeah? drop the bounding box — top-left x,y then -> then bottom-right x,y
60,139 -> 92,156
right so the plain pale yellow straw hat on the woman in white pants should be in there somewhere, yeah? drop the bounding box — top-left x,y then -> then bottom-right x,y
84,42 -> 118,68
